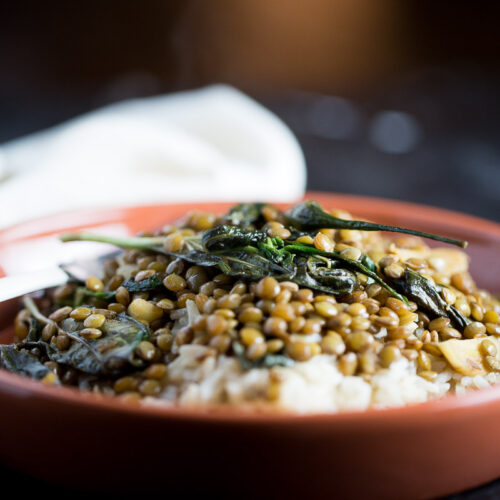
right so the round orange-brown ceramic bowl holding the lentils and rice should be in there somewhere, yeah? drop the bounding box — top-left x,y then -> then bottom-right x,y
0,193 -> 500,499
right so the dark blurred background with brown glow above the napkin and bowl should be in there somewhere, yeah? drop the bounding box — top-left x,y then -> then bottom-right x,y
0,0 -> 500,220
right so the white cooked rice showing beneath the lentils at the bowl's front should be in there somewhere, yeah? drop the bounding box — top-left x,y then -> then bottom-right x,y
141,345 -> 500,413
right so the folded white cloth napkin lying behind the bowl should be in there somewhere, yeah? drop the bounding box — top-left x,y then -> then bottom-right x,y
0,85 -> 306,227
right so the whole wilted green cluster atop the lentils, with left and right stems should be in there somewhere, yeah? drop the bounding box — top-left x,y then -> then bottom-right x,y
61,201 -> 466,306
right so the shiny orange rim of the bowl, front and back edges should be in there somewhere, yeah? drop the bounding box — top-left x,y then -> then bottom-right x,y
0,191 -> 500,428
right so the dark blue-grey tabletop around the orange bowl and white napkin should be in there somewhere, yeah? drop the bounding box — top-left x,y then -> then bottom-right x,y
0,70 -> 500,500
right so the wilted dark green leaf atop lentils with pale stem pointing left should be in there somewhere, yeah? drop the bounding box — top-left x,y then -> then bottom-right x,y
62,229 -> 406,301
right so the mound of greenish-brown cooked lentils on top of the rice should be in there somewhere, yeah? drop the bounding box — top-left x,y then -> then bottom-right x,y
9,211 -> 500,399
